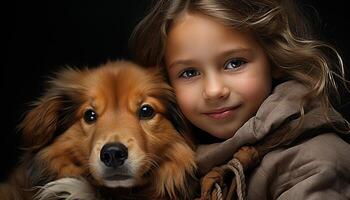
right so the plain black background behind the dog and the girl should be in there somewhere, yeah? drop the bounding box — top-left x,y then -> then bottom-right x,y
0,0 -> 350,180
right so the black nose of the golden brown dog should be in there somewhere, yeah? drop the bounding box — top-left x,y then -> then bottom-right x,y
100,143 -> 128,168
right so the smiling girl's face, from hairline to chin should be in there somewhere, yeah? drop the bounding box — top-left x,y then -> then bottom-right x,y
165,14 -> 272,139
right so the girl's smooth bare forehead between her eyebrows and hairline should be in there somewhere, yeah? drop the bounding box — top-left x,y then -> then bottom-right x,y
165,14 -> 260,57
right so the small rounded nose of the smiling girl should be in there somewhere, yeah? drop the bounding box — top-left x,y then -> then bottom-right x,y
203,76 -> 230,100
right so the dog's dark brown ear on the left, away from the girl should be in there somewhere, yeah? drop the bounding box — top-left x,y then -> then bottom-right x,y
19,68 -> 82,151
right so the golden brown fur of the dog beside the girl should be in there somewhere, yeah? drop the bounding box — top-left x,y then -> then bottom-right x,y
0,61 -> 195,199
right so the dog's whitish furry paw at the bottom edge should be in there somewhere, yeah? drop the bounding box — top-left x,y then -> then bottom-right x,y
34,178 -> 99,200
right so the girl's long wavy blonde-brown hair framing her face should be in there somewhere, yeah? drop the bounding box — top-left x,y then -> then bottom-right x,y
129,0 -> 348,126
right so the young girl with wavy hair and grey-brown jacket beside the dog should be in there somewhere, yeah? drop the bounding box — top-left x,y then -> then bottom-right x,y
130,0 -> 350,199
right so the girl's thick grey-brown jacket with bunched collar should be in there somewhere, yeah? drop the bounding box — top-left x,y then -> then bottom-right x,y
197,81 -> 350,200
